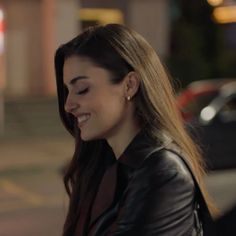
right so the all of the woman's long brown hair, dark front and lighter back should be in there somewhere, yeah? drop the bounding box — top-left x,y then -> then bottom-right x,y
55,24 -> 217,236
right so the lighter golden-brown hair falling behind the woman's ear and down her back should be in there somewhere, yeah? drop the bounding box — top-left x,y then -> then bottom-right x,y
98,24 -> 216,215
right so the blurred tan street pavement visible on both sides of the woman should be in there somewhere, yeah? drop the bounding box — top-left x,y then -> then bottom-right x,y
0,134 -> 236,236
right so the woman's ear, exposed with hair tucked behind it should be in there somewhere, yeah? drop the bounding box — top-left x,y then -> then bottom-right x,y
124,71 -> 140,99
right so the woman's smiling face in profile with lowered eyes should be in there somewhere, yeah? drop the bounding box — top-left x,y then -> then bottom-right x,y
63,56 -> 127,140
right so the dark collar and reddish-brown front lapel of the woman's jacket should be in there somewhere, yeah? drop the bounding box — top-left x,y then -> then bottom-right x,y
88,131 -> 168,235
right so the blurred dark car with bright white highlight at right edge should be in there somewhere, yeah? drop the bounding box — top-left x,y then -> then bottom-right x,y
187,80 -> 236,170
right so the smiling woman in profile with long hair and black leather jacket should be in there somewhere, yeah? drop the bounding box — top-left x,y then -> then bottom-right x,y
55,24 -> 217,236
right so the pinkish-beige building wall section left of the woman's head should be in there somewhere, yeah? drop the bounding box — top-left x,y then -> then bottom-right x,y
0,0 -> 80,97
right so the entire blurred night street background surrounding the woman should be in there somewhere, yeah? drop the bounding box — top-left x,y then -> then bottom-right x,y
0,0 -> 236,236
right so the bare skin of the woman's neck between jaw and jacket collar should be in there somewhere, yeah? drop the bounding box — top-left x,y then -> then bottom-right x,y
107,119 -> 140,159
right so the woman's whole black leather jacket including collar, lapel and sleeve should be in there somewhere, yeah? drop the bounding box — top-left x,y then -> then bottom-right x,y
79,132 -> 197,236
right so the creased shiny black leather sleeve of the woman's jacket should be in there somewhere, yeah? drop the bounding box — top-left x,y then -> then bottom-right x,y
108,152 -> 194,236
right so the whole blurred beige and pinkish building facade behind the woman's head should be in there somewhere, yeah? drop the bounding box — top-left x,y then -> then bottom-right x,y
0,0 -> 169,97
